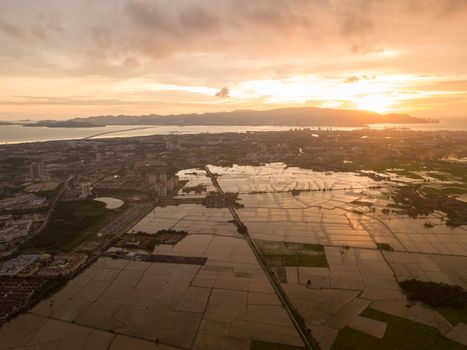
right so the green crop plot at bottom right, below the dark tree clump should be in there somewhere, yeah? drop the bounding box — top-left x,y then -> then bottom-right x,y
332,309 -> 465,350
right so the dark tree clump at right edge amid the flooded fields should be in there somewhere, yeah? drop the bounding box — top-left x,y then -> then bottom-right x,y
399,279 -> 467,309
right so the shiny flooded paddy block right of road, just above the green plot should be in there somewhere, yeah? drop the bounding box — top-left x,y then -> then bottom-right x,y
237,192 -> 376,248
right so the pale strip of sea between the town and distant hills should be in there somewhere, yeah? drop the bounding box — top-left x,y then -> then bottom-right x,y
0,120 -> 467,145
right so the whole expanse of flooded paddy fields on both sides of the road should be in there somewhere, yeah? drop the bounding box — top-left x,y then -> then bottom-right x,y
0,163 -> 467,350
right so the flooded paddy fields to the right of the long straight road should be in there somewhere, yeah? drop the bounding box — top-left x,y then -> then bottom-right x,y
210,163 -> 467,349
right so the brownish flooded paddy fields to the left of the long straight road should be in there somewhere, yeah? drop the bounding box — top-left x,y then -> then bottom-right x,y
4,201 -> 303,350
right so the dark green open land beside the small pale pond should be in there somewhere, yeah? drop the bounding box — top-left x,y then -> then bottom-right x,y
21,200 -> 125,251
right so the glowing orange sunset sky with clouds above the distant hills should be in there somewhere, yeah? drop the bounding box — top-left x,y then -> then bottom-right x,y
0,0 -> 467,123
